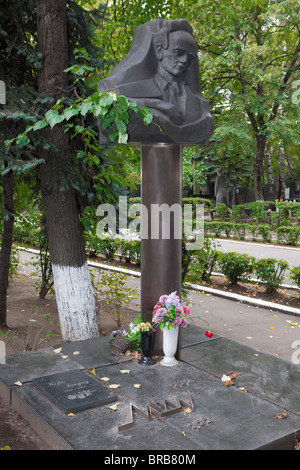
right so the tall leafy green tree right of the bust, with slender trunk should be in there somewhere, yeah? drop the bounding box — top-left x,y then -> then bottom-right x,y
184,0 -> 300,200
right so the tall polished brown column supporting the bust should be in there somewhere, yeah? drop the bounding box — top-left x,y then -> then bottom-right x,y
141,144 -> 182,359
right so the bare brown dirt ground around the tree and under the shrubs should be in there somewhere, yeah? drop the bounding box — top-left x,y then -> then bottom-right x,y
0,261 -> 300,450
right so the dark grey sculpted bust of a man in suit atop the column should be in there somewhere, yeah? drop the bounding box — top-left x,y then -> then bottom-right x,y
98,19 -> 214,145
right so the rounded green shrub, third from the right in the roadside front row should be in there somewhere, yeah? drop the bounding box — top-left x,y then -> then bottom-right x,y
218,252 -> 254,284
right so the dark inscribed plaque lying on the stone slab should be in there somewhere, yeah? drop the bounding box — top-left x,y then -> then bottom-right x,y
33,370 -> 117,413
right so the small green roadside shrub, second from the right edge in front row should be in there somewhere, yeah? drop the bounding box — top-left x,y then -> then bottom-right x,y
254,258 -> 289,294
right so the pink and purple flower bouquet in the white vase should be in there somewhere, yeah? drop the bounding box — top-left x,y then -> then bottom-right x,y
153,292 -> 190,330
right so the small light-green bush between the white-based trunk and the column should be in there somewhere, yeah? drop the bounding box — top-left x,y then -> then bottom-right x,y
93,271 -> 137,328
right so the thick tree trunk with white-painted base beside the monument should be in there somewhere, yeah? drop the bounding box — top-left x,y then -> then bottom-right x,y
37,0 -> 99,341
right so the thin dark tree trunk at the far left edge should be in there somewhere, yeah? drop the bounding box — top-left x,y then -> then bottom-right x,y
0,171 -> 14,326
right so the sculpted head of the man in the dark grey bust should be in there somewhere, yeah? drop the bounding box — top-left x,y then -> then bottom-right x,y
158,31 -> 197,78
